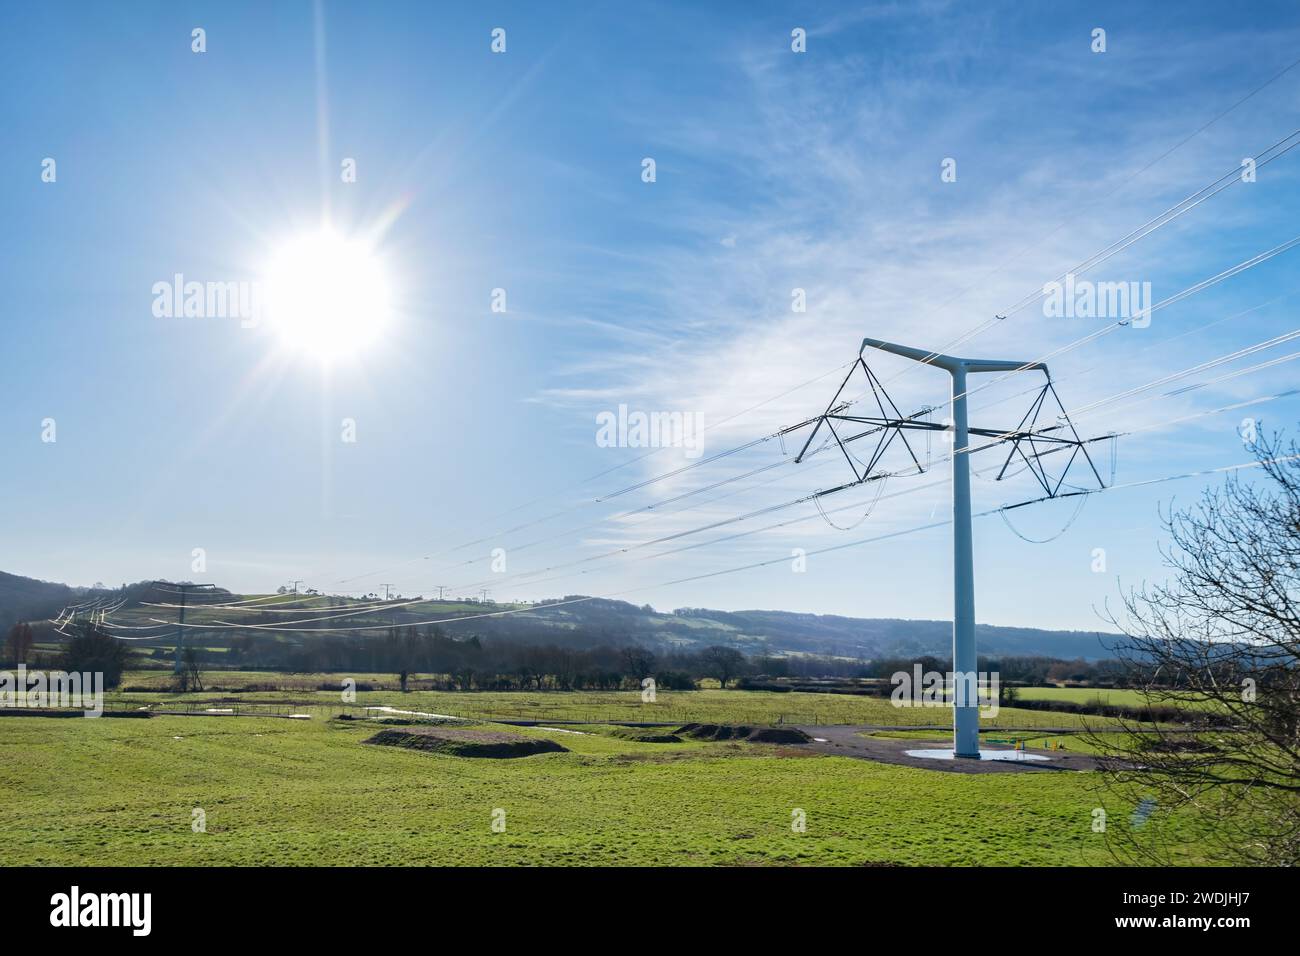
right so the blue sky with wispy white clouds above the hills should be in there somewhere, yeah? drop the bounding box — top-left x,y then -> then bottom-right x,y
0,3 -> 1300,628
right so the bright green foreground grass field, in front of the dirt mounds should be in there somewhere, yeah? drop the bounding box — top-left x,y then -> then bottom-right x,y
0,712 -> 1203,866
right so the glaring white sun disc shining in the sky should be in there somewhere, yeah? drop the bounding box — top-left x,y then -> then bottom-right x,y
265,229 -> 390,362
